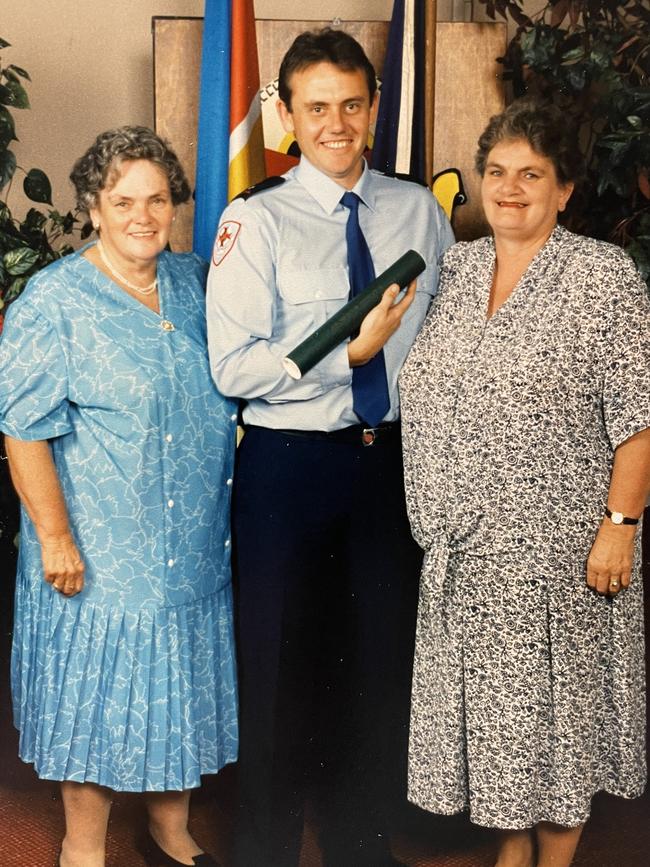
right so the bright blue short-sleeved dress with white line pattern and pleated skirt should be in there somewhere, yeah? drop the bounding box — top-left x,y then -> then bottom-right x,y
0,246 -> 237,791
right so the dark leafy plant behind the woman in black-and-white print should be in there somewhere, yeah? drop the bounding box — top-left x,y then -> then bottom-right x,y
480,0 -> 650,282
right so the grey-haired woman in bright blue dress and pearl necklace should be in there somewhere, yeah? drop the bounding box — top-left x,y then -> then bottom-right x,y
0,127 -> 237,867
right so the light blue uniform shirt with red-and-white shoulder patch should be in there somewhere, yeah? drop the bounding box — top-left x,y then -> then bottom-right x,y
207,157 -> 454,431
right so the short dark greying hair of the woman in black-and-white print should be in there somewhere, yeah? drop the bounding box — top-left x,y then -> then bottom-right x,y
475,96 -> 584,185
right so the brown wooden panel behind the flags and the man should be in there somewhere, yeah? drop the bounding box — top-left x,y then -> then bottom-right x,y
153,18 -> 506,250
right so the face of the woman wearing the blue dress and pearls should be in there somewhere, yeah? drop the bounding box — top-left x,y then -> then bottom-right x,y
90,160 -> 175,267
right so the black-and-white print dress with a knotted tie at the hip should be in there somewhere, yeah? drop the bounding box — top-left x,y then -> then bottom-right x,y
400,227 -> 650,829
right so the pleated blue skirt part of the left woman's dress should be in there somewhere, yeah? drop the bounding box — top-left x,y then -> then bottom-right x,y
12,581 -> 237,792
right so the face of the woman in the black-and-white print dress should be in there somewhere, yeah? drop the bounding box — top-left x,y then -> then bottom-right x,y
481,139 -> 573,243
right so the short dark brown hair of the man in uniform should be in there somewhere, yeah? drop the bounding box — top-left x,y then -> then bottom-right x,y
278,27 -> 377,111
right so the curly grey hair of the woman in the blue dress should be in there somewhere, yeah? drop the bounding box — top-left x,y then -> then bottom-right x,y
70,126 -> 190,211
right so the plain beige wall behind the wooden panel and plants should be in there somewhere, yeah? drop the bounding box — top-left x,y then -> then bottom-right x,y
0,0 -> 532,220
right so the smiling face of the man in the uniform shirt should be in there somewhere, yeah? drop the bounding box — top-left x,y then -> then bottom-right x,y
278,62 -> 377,190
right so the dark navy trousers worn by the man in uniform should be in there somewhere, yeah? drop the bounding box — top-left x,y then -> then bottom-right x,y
233,428 -> 421,867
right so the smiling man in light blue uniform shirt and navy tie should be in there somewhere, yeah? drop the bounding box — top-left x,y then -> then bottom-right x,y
208,29 -> 453,867
